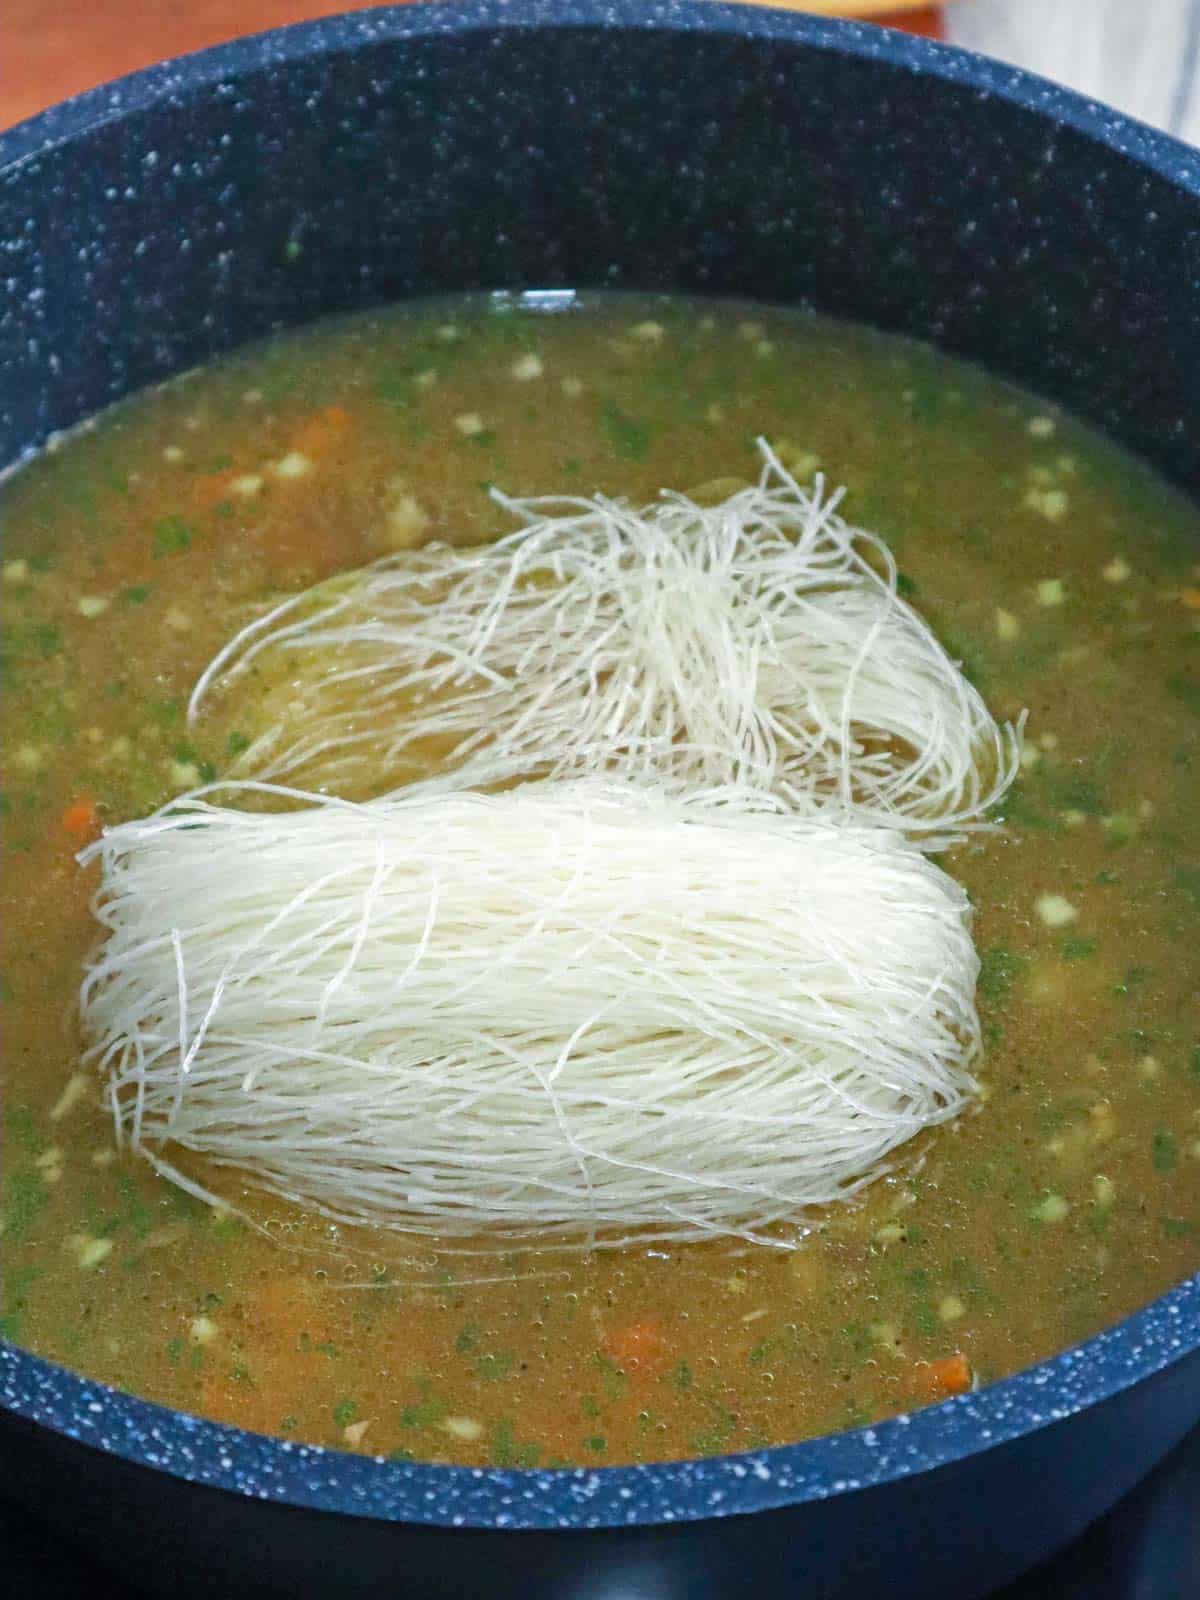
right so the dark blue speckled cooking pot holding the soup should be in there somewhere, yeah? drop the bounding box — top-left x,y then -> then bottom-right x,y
0,0 -> 1200,1600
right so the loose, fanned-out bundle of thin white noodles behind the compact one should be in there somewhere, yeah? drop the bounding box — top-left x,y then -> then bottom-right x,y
190,445 -> 1018,850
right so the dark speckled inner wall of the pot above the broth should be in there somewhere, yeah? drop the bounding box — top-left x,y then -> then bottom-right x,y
0,6 -> 1200,486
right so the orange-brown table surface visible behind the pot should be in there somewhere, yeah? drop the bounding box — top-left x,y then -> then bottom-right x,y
0,0 -> 939,128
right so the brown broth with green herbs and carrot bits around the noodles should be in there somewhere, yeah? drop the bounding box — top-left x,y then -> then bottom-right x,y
0,296 -> 1200,1466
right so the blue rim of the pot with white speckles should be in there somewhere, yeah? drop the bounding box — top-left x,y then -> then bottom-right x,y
0,0 -> 1200,1530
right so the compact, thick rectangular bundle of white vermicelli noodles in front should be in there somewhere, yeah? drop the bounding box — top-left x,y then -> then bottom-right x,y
82,781 -> 979,1243
